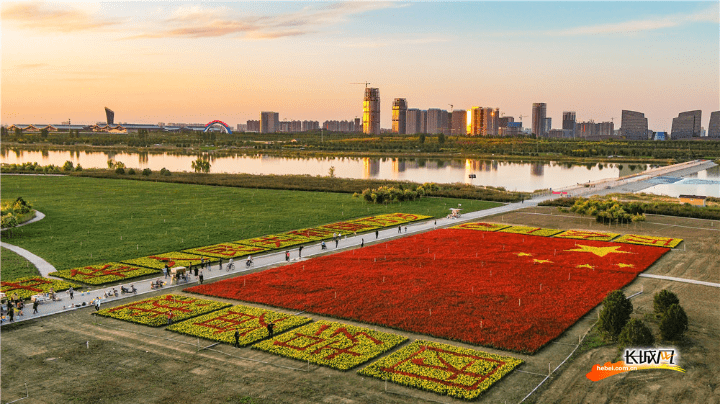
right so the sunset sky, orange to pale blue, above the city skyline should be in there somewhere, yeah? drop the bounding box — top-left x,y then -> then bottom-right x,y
0,1 -> 720,131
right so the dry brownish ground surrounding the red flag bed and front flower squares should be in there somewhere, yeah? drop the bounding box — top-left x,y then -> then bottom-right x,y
1,208 -> 720,403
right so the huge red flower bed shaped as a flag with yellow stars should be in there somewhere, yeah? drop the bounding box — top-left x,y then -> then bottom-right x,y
187,229 -> 668,352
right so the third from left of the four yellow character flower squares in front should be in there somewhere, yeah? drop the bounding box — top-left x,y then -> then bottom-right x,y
253,321 -> 407,370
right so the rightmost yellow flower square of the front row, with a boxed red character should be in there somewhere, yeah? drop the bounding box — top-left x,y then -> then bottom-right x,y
358,340 -> 522,400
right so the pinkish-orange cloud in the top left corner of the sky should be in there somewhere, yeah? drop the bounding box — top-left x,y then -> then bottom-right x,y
2,2 -> 116,33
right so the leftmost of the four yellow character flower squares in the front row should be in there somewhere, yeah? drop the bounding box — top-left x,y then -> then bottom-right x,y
96,295 -> 230,327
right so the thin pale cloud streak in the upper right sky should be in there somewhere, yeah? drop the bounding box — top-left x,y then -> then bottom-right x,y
546,4 -> 720,36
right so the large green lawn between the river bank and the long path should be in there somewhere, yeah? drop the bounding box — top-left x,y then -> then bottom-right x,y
2,175 -> 499,269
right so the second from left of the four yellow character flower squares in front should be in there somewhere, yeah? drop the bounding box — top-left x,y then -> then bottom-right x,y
167,306 -> 312,346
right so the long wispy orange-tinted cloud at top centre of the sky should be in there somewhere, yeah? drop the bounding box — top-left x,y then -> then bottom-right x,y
127,1 -> 405,39
